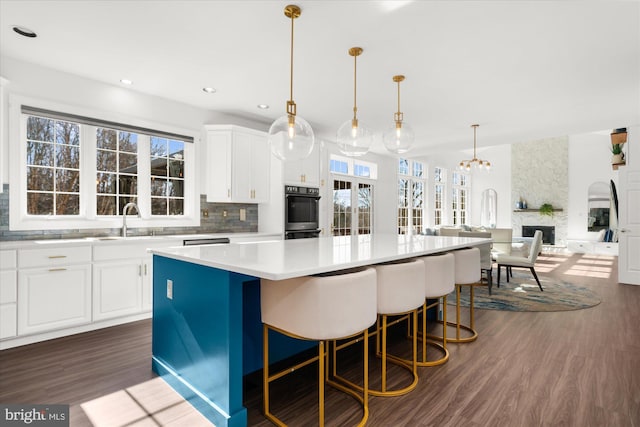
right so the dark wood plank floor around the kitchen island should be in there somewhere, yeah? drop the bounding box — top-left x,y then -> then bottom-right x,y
0,254 -> 640,426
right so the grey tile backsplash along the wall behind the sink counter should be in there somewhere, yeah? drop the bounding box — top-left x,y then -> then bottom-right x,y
0,184 -> 258,241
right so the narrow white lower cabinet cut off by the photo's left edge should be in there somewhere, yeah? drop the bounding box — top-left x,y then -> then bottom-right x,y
0,250 -> 18,340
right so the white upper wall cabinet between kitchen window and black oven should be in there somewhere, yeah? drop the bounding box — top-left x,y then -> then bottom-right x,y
204,125 -> 271,203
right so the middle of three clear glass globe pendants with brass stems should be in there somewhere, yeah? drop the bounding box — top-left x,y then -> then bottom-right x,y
336,47 -> 373,157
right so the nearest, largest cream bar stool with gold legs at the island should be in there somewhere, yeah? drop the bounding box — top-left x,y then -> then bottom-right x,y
260,268 -> 377,426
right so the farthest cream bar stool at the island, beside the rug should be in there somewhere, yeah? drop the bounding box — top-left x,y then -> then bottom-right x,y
446,248 -> 483,343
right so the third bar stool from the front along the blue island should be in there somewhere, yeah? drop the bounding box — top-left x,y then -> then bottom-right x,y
418,253 -> 456,366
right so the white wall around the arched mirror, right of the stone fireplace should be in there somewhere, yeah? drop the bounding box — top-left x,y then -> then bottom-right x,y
567,130 -> 618,240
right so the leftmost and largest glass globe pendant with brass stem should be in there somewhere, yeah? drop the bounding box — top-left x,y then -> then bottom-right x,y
269,5 -> 315,160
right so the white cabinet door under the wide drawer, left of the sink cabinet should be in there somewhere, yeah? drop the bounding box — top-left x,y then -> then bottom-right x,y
18,264 -> 91,335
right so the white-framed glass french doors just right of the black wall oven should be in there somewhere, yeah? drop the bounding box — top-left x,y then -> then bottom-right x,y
331,179 -> 373,236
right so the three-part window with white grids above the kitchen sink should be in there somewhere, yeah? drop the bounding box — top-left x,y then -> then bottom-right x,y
9,97 -> 199,230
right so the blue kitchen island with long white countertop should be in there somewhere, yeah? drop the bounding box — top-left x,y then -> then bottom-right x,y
152,234 -> 491,427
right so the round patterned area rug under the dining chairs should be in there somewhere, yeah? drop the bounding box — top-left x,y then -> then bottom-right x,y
447,271 -> 600,311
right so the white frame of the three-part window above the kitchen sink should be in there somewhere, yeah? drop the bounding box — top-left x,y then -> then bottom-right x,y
9,95 -> 200,230
